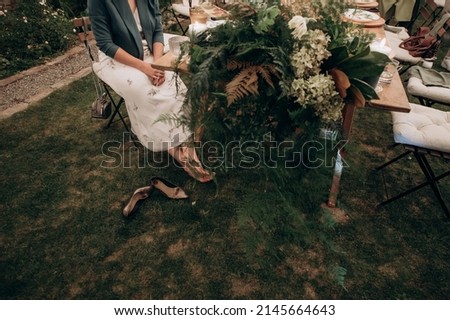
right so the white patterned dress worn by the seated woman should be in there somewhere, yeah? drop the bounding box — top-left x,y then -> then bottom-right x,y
94,9 -> 191,151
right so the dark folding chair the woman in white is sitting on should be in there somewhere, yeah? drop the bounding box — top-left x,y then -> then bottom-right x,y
72,17 -> 130,132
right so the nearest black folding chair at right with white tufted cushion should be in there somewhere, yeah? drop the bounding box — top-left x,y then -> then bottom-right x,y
376,104 -> 450,219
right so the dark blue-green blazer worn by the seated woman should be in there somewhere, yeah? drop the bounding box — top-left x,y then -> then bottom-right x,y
88,0 -> 164,60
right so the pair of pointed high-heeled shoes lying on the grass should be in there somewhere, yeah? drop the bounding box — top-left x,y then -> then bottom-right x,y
122,177 -> 189,218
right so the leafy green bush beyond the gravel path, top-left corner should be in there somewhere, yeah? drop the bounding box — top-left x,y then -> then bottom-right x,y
0,0 -> 74,78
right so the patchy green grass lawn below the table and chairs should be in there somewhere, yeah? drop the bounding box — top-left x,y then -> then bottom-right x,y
0,76 -> 450,299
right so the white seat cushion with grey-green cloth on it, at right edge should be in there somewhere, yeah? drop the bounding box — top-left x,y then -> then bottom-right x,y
406,66 -> 450,107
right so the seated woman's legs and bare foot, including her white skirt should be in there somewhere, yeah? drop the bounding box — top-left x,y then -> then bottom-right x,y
97,54 -> 214,182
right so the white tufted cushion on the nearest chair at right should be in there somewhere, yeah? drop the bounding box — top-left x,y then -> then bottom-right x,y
392,103 -> 450,152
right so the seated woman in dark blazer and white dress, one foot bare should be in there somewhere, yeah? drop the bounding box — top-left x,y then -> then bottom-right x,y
88,0 -> 213,182
